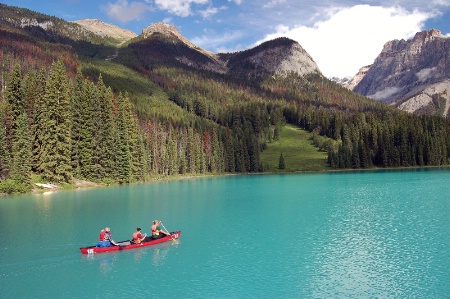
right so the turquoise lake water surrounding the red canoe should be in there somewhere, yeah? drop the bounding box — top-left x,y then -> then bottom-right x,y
0,168 -> 450,298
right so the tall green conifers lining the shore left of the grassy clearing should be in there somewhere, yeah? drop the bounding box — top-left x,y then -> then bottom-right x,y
0,60 -> 280,190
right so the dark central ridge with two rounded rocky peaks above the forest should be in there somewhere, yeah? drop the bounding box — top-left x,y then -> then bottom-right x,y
119,23 -> 320,80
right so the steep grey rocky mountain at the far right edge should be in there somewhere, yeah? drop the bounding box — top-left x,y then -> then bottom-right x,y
349,29 -> 450,116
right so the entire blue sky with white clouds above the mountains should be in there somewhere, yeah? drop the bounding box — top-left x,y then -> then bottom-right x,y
0,0 -> 450,78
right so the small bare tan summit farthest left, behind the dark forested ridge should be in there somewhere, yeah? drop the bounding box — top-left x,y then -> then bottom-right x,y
73,19 -> 137,42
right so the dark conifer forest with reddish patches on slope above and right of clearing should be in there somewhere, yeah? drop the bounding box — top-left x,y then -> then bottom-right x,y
149,67 -> 450,169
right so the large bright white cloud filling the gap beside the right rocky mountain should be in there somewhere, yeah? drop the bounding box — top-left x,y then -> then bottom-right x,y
258,5 -> 433,78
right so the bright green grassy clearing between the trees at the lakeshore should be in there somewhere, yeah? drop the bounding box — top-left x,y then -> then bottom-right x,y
261,125 -> 330,172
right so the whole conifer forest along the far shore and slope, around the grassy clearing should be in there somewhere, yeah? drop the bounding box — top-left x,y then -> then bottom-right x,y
0,42 -> 450,191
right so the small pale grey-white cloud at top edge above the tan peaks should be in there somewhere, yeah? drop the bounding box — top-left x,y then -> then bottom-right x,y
101,0 -> 152,23
